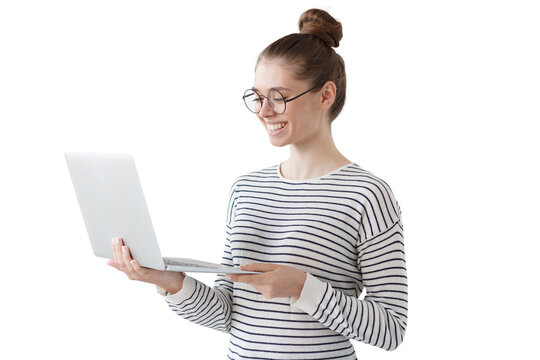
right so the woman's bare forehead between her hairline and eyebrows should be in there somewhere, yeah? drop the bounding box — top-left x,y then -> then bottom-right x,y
253,59 -> 302,91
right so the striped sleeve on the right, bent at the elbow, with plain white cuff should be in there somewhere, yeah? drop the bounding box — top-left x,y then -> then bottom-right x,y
291,184 -> 408,350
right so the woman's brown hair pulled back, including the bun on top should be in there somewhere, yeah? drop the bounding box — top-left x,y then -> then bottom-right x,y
257,9 -> 347,122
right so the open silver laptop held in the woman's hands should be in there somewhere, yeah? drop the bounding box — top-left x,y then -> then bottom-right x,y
64,152 -> 258,274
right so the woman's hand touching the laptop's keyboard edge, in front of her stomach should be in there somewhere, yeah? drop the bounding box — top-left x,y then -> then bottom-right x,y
228,263 -> 307,301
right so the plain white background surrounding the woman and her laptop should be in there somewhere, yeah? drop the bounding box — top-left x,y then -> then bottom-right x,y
0,0 -> 540,359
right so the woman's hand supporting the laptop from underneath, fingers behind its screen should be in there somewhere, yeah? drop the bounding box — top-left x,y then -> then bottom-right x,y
107,238 -> 184,294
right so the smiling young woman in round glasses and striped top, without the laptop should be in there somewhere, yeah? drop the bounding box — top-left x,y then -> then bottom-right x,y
109,9 -> 407,359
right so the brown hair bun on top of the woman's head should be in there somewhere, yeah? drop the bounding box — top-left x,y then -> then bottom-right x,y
298,9 -> 343,47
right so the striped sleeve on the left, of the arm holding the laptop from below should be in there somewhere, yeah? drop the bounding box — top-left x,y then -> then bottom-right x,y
158,182 -> 236,332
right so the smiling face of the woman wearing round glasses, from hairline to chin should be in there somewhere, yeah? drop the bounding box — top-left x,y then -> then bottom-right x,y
253,59 -> 323,146
